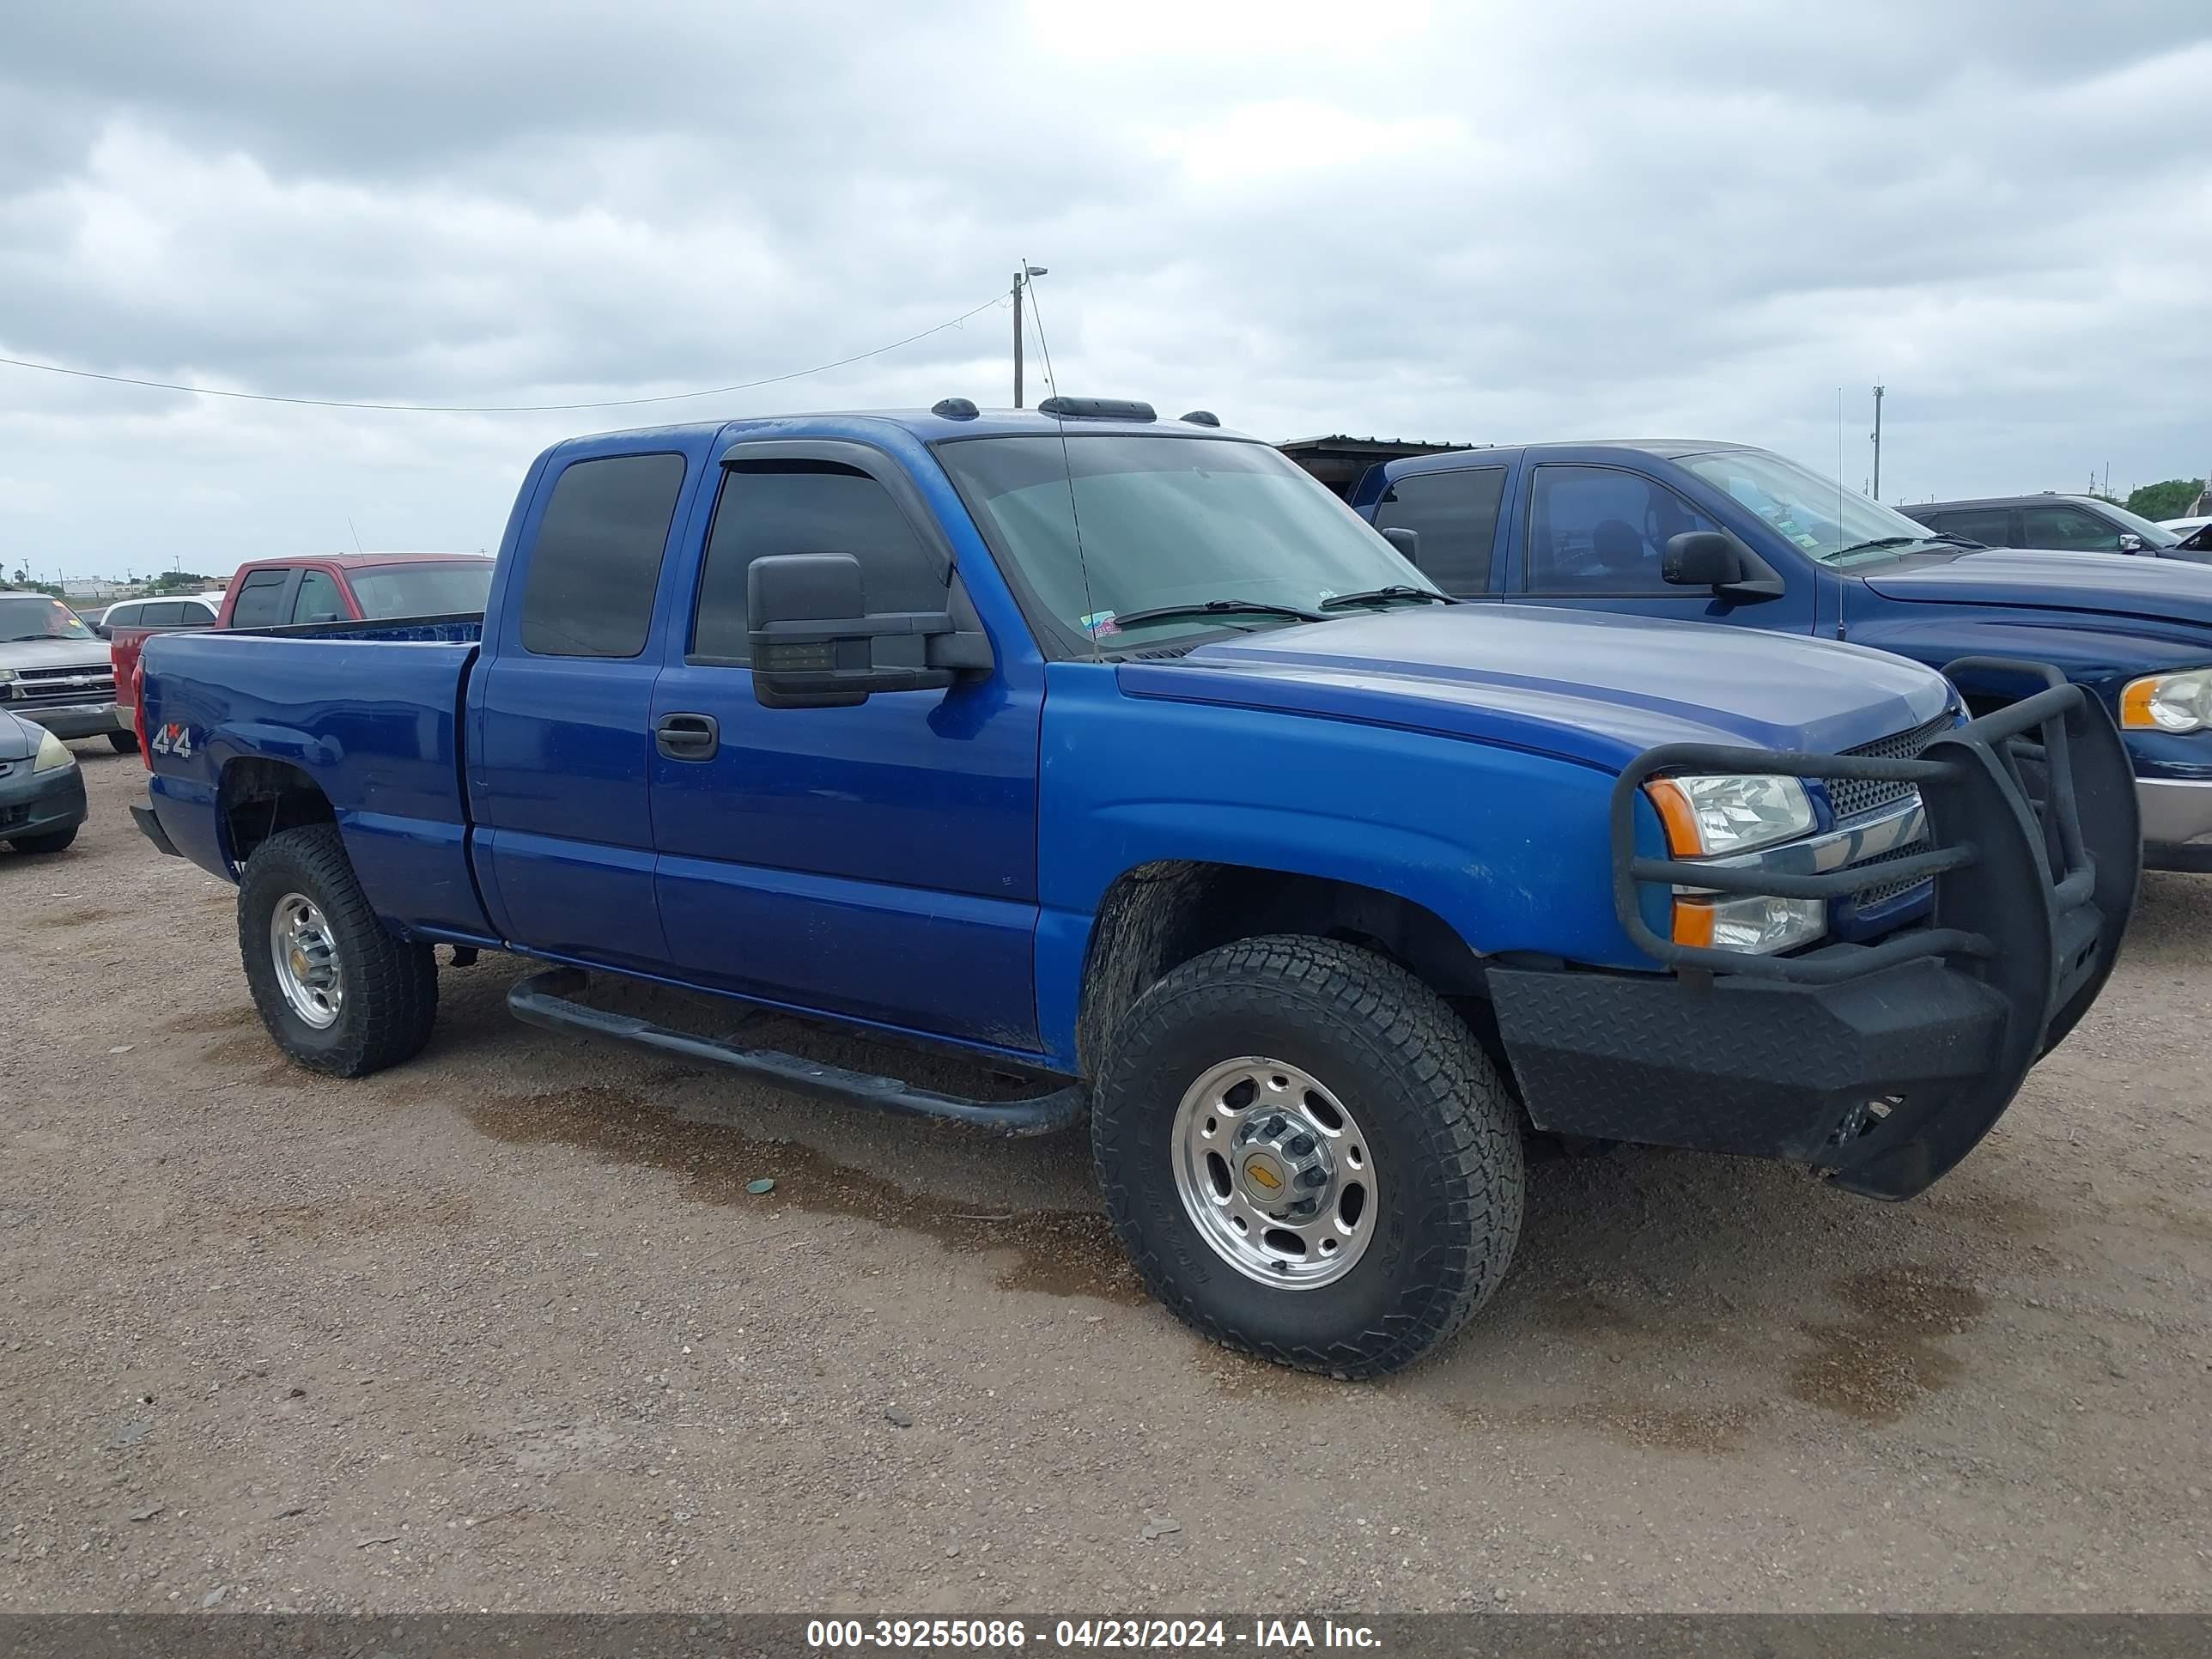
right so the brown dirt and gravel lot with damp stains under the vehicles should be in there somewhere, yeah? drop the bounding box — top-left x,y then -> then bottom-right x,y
0,745 -> 2212,1613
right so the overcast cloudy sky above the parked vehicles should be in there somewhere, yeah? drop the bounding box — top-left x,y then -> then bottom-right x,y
0,0 -> 2212,575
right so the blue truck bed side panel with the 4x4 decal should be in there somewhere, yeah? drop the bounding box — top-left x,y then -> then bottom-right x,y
142,617 -> 491,936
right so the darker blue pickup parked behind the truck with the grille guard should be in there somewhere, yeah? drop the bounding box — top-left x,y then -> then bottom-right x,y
1352,442 -> 2212,872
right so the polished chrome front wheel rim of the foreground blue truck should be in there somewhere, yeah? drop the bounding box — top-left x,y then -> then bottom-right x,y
1170,1055 -> 1380,1290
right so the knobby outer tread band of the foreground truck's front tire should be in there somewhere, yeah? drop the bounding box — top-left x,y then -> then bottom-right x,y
1091,933 -> 1526,1378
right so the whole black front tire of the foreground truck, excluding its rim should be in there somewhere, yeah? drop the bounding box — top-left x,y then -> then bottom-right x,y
1091,936 -> 1524,1378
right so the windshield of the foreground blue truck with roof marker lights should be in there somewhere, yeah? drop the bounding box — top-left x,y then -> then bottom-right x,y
938,434 -> 1436,648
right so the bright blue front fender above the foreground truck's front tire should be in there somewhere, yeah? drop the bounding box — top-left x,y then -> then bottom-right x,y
1037,664 -> 1650,1061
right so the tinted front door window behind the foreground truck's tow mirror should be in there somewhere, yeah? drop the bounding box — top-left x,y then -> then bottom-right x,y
690,460 -> 945,661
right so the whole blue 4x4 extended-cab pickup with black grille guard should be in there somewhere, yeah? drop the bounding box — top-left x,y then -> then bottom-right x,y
135,398 -> 2139,1376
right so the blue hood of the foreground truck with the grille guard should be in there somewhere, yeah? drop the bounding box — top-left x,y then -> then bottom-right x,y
1119,604 -> 1951,769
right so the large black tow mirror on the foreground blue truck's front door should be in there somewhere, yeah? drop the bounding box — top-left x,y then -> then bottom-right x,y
745,553 -> 991,708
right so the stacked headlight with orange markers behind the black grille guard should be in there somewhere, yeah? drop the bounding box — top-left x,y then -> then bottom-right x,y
1644,775 -> 1827,956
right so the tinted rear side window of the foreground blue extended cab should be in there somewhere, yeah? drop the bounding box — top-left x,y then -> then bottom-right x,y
522,456 -> 684,657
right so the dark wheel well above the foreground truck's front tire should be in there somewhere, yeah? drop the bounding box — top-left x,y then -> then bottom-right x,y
1075,858 -> 1484,1078
